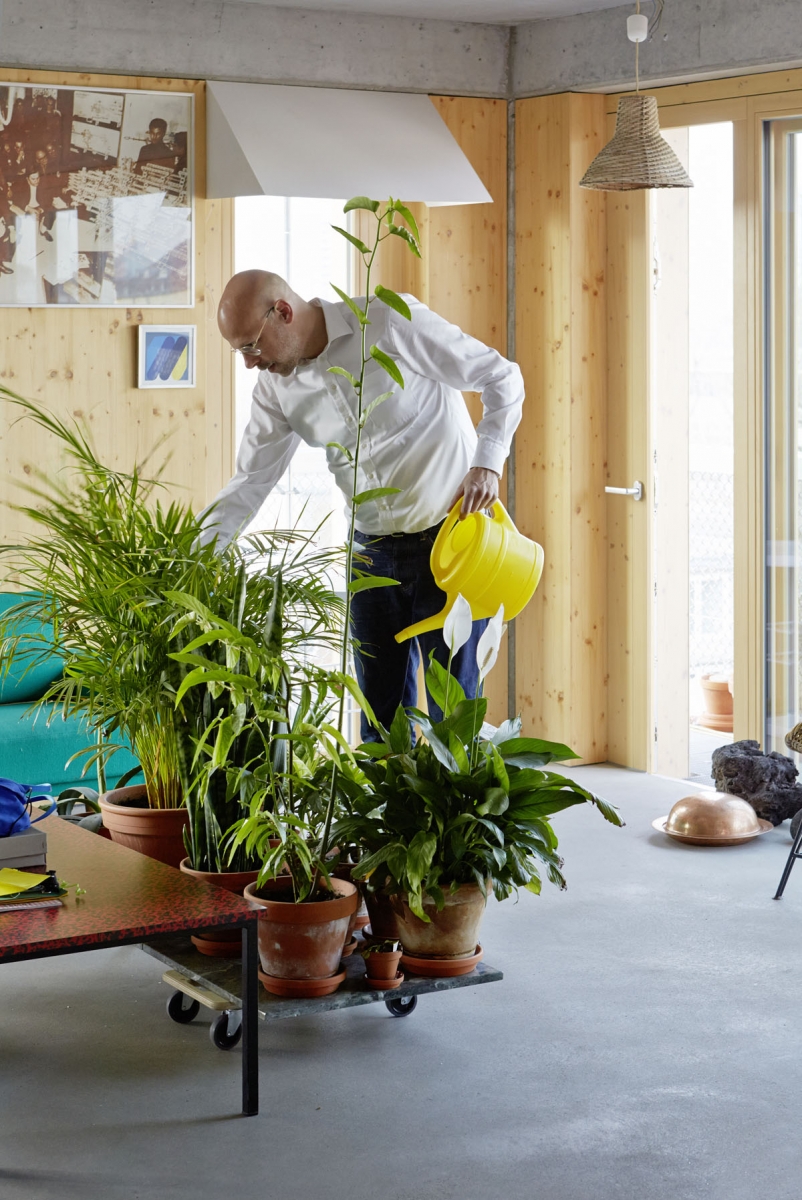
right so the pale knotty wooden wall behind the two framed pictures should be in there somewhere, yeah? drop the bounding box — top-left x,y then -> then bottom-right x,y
0,70 -> 233,540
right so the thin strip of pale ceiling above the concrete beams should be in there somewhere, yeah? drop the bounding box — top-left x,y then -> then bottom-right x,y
231,0 -> 628,25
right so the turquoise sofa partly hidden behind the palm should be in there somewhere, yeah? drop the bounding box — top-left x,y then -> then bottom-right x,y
0,592 -> 142,796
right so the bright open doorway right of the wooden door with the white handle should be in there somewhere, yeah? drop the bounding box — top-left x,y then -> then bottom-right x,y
648,121 -> 735,782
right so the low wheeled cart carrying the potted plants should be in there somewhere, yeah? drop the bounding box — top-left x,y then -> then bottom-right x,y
142,935 -> 504,1050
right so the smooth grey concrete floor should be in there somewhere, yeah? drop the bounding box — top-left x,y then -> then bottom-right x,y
0,767 -> 802,1200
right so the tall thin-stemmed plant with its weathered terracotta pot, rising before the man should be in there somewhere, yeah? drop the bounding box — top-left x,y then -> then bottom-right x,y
217,196 -> 420,995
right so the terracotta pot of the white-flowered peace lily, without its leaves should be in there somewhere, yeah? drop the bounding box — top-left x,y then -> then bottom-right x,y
393,880 -> 492,958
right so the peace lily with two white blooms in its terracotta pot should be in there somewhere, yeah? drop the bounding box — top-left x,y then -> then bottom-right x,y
335,596 -> 623,974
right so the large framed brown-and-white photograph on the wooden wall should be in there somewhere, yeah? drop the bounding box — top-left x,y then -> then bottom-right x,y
0,83 -> 193,308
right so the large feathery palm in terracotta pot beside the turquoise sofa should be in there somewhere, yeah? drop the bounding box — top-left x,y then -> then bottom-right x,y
0,390 -> 342,874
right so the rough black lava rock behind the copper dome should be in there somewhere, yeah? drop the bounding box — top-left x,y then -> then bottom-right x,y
713,742 -> 802,826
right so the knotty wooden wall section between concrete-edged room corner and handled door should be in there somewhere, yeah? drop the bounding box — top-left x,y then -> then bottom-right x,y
515,95 -> 608,762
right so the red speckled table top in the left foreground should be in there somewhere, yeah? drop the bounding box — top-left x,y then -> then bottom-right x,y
0,816 -> 256,961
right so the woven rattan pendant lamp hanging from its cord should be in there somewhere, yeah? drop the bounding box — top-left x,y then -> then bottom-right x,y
580,0 -> 694,192
